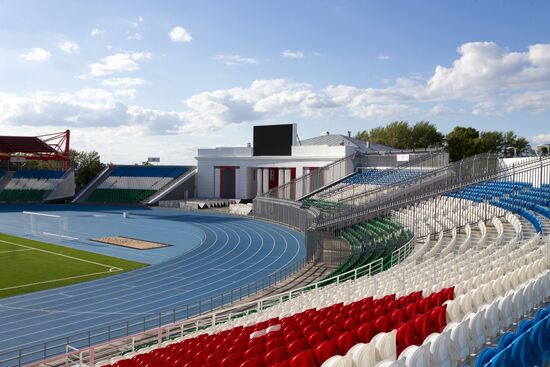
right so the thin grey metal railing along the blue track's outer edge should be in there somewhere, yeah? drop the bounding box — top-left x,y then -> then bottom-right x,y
0,258 -> 306,367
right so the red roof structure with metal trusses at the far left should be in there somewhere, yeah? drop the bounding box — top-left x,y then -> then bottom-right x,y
0,130 -> 71,169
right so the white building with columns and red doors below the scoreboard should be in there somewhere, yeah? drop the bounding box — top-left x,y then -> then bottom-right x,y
196,126 -> 391,199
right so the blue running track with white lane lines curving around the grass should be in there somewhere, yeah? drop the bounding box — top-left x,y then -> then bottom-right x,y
0,206 -> 306,367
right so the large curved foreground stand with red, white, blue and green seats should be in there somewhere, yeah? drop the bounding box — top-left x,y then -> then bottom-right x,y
12,153 -> 550,367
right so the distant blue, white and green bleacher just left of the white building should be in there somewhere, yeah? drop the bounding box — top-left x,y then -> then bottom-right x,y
86,166 -> 189,203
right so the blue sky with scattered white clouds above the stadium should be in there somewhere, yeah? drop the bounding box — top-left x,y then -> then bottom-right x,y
0,0 -> 550,163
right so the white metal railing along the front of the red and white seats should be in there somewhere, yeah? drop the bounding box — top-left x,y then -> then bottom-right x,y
17,236 -> 414,367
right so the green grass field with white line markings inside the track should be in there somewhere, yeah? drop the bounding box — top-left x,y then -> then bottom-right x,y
0,234 -> 146,298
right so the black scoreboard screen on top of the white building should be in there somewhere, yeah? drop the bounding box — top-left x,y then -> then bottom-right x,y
253,124 -> 295,156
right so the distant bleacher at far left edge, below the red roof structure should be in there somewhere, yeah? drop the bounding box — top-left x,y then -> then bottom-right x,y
0,170 -> 65,202
